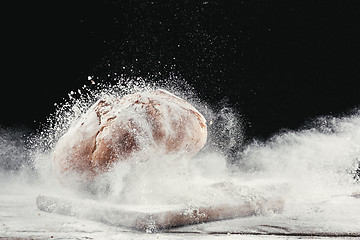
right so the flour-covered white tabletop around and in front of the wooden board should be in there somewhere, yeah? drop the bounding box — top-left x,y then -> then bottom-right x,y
0,172 -> 360,239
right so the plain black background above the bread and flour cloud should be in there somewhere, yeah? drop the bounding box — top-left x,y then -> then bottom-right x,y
0,0 -> 360,142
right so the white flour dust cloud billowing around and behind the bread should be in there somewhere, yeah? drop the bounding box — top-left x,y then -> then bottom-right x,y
0,77 -> 360,218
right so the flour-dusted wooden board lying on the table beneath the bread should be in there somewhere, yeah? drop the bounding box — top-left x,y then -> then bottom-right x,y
36,195 -> 284,232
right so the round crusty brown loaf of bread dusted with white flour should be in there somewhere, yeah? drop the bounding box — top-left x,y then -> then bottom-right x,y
53,90 -> 207,181
